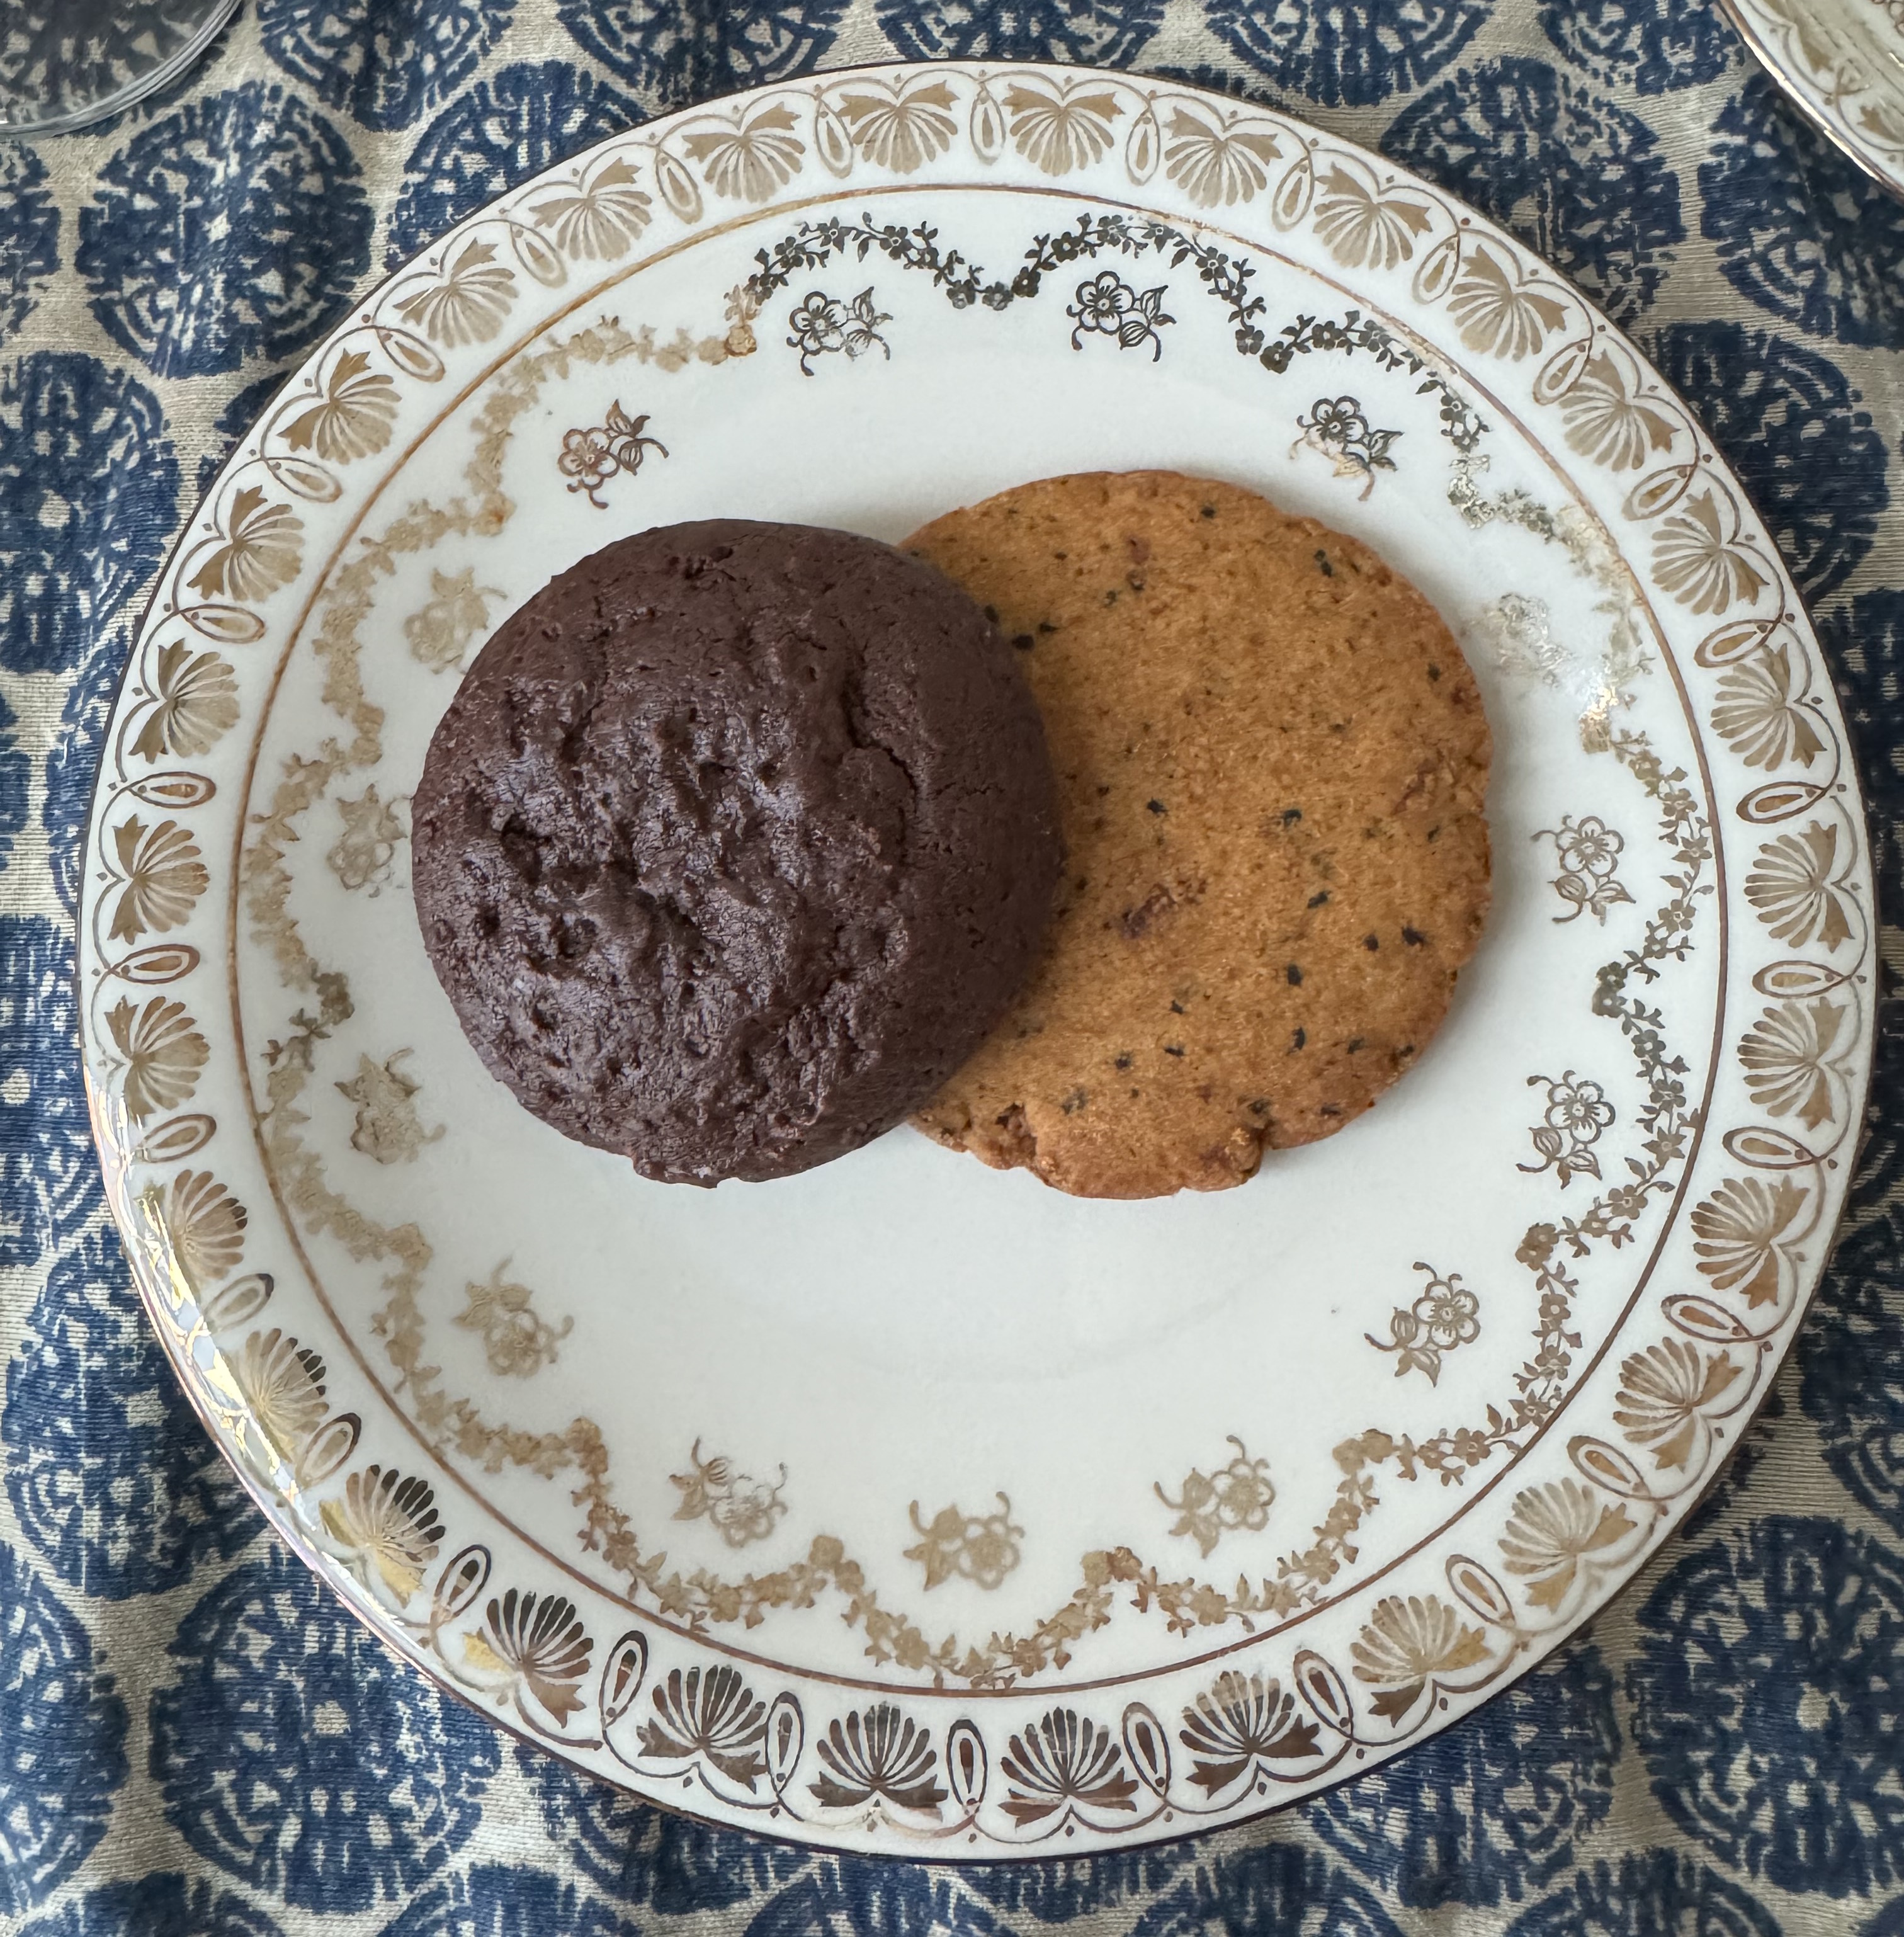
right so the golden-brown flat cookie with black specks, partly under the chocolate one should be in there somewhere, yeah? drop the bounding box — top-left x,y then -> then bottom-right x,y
905,470 -> 1490,1197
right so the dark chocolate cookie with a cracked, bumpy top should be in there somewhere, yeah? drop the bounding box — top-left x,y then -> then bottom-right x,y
412,519 -> 1062,1183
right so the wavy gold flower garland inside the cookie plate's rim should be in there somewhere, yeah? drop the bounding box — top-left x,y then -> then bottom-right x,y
226,217 -> 1706,1687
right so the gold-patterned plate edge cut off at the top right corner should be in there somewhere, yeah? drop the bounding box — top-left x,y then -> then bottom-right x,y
1722,0 -> 1904,196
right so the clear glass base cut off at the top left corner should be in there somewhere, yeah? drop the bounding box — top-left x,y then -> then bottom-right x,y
0,0 -> 238,137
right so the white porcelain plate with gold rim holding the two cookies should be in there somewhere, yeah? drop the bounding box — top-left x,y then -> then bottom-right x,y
79,66 -> 1875,1858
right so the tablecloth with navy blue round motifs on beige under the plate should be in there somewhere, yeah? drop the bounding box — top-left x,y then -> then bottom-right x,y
0,0 -> 1904,1937
